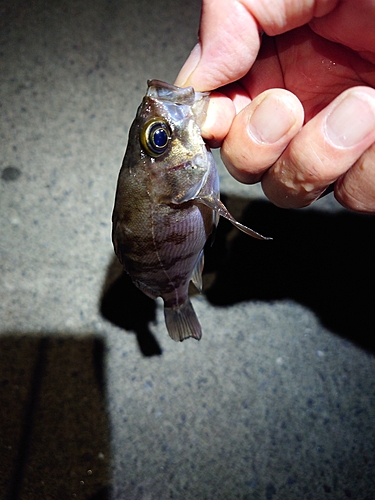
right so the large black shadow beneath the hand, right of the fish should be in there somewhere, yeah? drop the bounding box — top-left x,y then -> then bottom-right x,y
206,199 -> 375,352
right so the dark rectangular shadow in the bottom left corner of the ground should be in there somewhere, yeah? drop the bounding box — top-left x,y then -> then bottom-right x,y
0,334 -> 111,500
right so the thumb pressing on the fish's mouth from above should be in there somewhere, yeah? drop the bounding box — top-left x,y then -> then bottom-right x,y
175,0 -> 260,91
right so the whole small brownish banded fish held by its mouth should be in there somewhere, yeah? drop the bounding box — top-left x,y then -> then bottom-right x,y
112,80 -> 270,341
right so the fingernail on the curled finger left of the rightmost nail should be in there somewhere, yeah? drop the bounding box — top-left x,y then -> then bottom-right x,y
248,96 -> 295,144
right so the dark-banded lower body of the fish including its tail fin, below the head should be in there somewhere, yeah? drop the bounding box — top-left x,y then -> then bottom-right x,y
120,202 -> 212,340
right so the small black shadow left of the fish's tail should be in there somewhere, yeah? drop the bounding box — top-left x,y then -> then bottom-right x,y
100,256 -> 162,357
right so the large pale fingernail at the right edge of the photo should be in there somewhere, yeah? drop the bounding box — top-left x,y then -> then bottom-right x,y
326,92 -> 375,148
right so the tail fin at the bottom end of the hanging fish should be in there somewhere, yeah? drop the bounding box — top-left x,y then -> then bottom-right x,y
164,299 -> 202,342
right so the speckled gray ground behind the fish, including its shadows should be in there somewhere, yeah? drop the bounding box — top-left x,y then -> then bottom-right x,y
0,0 -> 375,500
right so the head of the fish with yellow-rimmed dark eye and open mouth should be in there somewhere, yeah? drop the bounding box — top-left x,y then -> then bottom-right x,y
126,80 -> 210,204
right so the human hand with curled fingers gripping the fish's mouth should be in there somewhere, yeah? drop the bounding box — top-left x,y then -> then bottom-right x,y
176,0 -> 375,213
